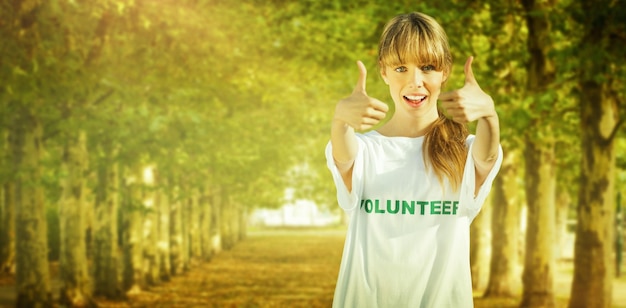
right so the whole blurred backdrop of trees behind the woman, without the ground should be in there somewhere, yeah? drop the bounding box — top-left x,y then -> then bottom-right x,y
0,0 -> 626,307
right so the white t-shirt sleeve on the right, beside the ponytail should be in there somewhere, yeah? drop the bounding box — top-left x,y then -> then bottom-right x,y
461,136 -> 503,219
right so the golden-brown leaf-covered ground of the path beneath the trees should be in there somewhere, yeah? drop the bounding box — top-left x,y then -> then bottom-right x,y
0,229 -> 626,308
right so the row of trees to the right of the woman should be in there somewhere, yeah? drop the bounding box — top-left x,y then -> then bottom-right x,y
458,0 -> 626,307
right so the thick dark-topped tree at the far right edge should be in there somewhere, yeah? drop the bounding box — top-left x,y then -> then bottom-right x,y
569,1 -> 626,307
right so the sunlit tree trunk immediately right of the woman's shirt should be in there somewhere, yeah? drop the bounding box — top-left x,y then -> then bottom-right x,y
470,199 -> 492,291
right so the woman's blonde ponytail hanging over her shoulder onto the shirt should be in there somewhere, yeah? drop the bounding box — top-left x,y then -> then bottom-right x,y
423,111 -> 469,191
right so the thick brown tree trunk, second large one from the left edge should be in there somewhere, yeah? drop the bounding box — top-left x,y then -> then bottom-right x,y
59,131 -> 95,307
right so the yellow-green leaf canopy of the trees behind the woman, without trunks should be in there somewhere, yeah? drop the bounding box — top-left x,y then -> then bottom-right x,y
0,0 -> 626,212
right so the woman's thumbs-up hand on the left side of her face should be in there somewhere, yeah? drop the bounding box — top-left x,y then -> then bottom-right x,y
334,61 -> 389,131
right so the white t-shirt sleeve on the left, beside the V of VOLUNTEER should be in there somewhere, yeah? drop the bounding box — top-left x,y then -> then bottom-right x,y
326,138 -> 363,211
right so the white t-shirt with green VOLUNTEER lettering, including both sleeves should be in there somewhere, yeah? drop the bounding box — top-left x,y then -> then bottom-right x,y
326,131 -> 502,308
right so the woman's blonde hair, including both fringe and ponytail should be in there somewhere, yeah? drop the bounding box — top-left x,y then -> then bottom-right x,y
378,12 -> 469,191
